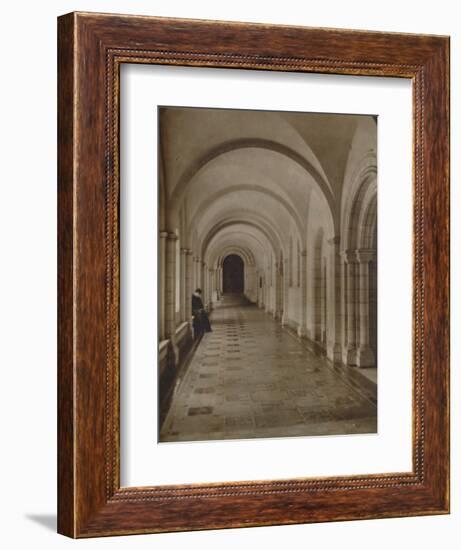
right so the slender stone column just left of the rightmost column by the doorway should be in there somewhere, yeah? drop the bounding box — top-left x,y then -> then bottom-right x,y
342,250 -> 357,365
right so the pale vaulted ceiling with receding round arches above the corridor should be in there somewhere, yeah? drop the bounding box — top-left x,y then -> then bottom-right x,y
159,107 -> 376,270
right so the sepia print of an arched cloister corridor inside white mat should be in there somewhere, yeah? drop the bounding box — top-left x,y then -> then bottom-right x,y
156,106 -> 378,443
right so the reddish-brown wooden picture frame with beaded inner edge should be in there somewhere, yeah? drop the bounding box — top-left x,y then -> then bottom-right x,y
58,13 -> 449,537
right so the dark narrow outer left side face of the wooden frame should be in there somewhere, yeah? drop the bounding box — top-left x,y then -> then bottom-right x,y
58,18 -> 75,536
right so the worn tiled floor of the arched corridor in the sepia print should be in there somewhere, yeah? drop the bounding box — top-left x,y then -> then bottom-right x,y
160,296 -> 376,441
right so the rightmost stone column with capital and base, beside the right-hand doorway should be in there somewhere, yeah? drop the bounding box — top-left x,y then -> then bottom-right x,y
356,249 -> 375,367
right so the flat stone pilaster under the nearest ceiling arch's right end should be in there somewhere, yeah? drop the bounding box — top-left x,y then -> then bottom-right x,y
327,237 -> 342,361
